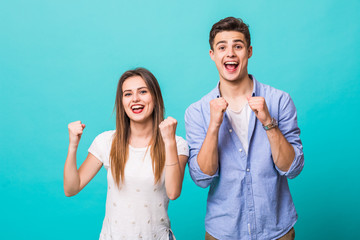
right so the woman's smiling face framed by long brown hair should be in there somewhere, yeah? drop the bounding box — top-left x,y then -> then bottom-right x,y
122,76 -> 154,123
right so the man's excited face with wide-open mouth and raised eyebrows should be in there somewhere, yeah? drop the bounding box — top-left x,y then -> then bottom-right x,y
210,31 -> 252,81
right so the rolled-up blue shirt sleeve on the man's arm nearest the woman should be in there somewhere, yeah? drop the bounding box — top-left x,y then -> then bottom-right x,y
185,103 -> 219,188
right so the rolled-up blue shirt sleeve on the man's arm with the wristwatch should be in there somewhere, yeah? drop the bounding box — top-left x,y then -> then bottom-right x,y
275,94 -> 304,179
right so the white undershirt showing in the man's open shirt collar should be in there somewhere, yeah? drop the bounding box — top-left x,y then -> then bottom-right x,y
226,103 -> 251,154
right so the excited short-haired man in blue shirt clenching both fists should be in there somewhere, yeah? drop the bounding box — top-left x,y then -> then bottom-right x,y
185,17 -> 304,240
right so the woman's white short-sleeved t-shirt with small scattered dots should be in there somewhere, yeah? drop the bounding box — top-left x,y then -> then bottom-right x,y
89,130 -> 189,240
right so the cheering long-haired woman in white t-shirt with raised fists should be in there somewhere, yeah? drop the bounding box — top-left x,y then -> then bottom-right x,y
64,68 -> 189,240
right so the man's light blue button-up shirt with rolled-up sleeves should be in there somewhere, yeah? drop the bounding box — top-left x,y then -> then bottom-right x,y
185,75 -> 304,240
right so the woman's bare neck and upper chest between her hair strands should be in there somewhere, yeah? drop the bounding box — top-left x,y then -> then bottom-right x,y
129,119 -> 153,148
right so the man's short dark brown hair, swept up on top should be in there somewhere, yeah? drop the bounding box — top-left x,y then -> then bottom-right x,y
209,17 -> 251,50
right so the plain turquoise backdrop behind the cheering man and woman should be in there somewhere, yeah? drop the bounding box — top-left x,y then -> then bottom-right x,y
0,0 -> 360,240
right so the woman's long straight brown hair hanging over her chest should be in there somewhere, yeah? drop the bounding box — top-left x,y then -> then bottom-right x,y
110,68 -> 165,187
